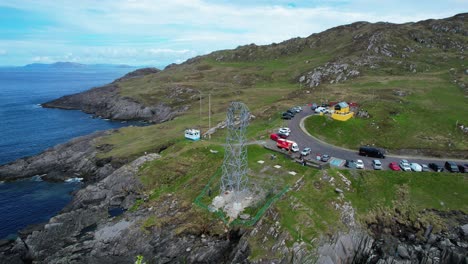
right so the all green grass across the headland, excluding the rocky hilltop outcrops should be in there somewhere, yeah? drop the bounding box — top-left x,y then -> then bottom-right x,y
92,14 -> 468,258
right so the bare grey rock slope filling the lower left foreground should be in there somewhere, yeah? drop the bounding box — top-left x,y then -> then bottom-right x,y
0,154 -> 248,264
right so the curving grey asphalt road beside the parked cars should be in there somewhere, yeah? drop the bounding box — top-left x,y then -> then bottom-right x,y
288,106 -> 468,170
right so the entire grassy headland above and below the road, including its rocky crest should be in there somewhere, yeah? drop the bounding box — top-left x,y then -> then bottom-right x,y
88,15 -> 468,260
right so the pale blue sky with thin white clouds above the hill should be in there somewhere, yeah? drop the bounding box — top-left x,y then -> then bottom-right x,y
0,0 -> 468,66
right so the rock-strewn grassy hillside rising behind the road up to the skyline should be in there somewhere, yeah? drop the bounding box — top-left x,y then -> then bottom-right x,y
106,15 -> 468,159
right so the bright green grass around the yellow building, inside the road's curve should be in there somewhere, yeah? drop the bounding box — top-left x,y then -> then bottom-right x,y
305,74 -> 468,153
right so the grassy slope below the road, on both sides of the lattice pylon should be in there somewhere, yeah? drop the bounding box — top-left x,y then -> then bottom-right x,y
126,140 -> 468,259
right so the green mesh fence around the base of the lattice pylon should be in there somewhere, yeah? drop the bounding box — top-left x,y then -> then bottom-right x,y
194,168 -> 289,227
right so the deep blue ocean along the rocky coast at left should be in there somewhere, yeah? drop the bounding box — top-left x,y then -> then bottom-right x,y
0,67 -> 139,239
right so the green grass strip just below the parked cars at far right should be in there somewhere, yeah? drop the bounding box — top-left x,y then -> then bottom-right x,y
346,171 -> 468,214
